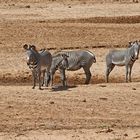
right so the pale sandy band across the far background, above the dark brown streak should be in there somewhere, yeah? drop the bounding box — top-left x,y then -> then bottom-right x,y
0,3 -> 140,20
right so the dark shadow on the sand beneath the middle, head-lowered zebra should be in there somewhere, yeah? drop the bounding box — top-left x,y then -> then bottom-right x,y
52,85 -> 77,91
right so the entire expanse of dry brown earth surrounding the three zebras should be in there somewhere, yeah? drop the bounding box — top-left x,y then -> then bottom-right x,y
0,0 -> 140,140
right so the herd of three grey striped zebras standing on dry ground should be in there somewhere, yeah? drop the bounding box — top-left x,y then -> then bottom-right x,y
23,41 -> 140,89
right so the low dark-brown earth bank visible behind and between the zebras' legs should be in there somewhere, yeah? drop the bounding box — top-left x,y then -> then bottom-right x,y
0,73 -> 140,85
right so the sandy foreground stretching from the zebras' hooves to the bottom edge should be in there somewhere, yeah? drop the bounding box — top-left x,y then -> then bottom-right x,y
0,82 -> 140,139
